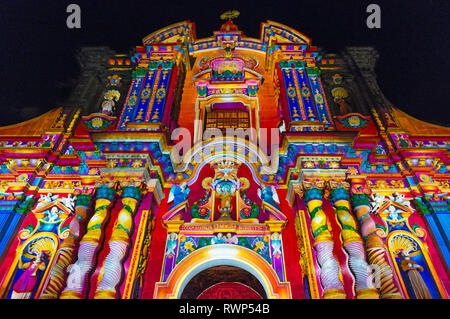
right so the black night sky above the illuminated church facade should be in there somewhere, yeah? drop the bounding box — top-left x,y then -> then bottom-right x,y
0,0 -> 450,126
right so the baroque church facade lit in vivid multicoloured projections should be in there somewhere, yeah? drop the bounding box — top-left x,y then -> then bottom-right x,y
0,20 -> 450,299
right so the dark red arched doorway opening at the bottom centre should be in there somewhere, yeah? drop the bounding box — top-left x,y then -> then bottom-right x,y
181,265 -> 267,299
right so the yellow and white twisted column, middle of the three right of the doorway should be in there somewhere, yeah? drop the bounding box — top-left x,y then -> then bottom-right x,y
329,182 -> 379,299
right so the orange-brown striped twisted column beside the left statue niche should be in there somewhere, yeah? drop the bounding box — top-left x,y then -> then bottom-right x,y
41,194 -> 92,299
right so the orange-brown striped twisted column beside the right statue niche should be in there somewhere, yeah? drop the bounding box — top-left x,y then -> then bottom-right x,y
351,188 -> 402,299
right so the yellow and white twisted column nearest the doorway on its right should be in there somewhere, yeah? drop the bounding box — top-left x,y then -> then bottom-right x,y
303,183 -> 346,299
